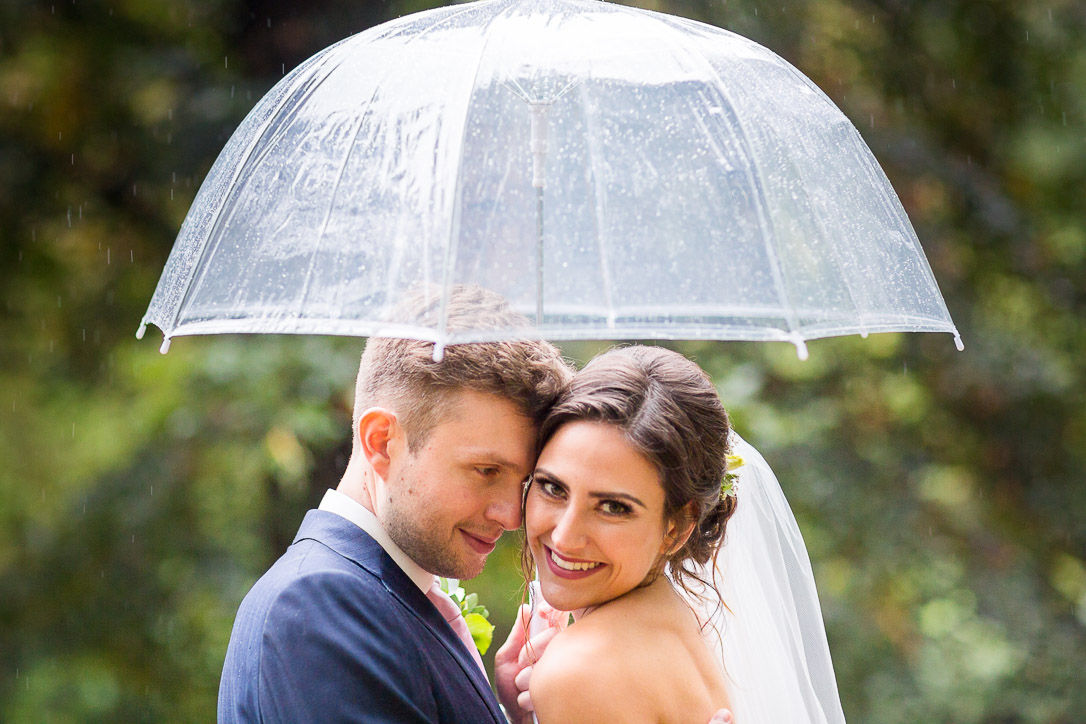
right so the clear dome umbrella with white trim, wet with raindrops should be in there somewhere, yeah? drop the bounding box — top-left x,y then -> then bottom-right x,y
140,0 -> 961,356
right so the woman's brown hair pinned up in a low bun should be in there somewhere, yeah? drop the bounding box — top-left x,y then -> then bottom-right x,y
522,345 -> 736,599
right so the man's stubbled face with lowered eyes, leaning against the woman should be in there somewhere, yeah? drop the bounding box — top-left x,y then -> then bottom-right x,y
378,391 -> 536,579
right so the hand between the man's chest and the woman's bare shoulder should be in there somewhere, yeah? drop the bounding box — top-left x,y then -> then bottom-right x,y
494,604 -> 568,724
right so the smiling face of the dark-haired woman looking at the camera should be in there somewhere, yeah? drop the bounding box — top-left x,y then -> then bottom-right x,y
525,422 -> 674,611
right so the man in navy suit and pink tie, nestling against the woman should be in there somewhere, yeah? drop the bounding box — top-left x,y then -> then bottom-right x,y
218,288 -> 570,723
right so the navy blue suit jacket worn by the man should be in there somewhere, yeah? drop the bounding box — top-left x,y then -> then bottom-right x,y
218,510 -> 505,724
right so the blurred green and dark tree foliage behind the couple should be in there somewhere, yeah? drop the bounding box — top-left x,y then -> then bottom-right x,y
0,0 -> 1086,724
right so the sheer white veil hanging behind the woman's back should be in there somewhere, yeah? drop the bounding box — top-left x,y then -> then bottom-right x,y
695,433 -> 845,724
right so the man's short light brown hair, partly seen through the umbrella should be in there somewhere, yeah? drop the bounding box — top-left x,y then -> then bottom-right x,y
353,285 -> 572,449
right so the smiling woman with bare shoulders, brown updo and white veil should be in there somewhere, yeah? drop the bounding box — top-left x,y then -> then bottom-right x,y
512,346 -> 844,724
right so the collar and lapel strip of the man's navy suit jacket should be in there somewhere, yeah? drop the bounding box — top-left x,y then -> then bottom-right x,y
294,510 -> 506,722
